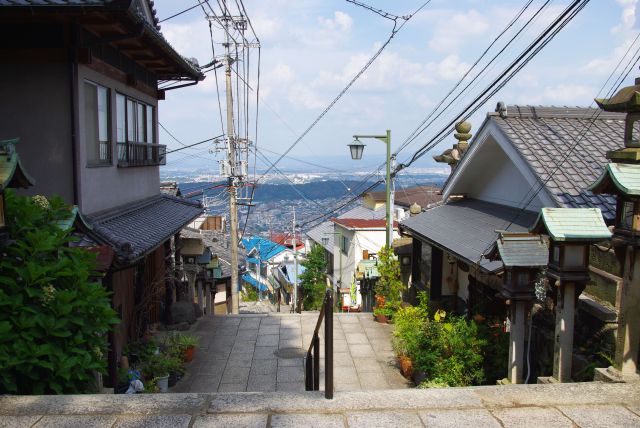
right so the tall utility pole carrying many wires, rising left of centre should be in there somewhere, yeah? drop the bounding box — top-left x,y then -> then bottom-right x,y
222,0 -> 240,314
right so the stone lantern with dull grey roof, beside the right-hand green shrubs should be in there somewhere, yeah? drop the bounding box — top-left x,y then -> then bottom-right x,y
485,231 -> 549,383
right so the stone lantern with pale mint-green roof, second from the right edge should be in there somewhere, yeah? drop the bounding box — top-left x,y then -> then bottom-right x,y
531,208 -> 611,382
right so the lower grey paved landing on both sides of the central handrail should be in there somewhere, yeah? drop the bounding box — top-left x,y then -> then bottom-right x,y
171,312 -> 409,392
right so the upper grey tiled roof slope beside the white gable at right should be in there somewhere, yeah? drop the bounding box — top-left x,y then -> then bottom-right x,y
490,106 -> 625,220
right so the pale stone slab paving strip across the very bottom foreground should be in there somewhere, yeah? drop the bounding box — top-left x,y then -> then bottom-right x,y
0,383 -> 640,428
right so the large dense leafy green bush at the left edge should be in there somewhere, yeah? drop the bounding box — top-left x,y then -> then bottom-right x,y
0,191 -> 118,394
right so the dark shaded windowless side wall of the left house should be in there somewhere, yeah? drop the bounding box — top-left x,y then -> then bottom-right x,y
0,63 -> 73,204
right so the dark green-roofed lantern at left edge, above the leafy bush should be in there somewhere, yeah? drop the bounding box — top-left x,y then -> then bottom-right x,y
0,138 -> 34,245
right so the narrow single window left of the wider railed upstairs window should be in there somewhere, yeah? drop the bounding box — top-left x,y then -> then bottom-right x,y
84,82 -> 111,164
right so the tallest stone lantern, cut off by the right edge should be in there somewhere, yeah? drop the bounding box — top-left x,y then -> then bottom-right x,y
589,79 -> 640,381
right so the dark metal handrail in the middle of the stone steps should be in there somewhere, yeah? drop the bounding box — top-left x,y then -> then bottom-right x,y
304,290 -> 333,399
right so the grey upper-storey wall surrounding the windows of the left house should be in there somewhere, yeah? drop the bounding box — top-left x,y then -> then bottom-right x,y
78,65 -> 160,214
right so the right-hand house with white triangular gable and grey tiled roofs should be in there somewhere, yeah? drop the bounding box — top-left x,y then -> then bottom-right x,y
400,106 -> 624,314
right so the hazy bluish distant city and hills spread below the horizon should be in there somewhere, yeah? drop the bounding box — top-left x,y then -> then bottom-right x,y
161,168 -> 448,238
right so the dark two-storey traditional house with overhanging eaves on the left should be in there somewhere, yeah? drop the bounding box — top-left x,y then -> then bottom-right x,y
0,0 -> 204,379
